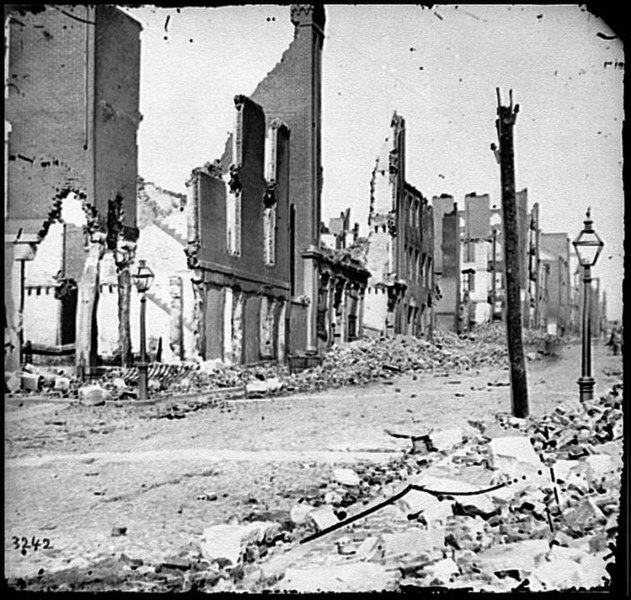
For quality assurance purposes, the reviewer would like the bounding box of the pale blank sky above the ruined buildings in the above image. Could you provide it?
[124,4,624,319]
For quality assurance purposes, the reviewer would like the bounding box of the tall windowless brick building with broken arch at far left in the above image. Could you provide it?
[5,5,141,370]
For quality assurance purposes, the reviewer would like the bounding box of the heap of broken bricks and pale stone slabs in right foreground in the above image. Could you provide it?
[178,384,623,592]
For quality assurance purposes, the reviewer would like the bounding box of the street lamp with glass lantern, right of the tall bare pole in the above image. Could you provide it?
[572,208,605,402]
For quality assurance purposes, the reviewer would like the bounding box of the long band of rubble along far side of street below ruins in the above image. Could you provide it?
[5,324,569,406]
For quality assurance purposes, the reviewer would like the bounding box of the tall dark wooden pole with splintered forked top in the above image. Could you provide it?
[491,88,529,419]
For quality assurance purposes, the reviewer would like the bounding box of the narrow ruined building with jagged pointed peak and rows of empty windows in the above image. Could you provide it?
[364,112,436,336]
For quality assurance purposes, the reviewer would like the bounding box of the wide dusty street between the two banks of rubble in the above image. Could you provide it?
[5,345,622,592]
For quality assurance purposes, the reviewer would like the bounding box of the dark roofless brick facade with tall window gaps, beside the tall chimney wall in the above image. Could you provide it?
[187,96,291,363]
